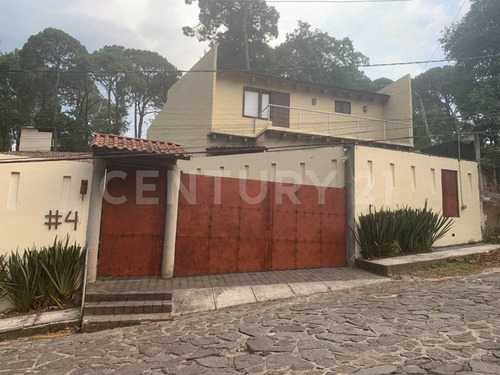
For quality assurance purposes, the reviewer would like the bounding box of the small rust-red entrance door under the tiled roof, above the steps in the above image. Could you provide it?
[97,168,166,277]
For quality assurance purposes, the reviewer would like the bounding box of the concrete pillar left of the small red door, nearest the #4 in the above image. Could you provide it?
[86,159,106,283]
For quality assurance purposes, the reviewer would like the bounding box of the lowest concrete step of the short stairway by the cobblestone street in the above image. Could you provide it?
[82,314,172,332]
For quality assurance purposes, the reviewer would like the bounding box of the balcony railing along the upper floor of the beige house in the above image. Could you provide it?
[254,104,413,145]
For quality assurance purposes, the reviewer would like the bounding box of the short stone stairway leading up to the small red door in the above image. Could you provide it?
[82,281,172,332]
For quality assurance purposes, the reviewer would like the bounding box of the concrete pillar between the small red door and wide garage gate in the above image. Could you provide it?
[161,165,181,279]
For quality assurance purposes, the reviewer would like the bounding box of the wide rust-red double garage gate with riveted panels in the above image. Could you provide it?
[175,174,346,276]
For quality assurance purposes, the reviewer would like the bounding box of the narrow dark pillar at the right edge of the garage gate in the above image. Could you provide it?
[344,145,356,267]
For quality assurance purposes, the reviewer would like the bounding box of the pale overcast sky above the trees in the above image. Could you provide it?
[0,0,469,79]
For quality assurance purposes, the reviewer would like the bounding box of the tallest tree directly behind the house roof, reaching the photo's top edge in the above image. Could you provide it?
[183,0,279,69]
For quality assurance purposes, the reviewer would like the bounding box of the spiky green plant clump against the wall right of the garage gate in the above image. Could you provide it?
[354,202,453,258]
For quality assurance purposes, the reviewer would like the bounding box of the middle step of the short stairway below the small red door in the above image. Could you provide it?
[83,300,172,317]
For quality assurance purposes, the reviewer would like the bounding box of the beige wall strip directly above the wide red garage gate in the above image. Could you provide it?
[178,147,344,187]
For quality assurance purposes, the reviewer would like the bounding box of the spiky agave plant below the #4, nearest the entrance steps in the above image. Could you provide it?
[41,236,85,300]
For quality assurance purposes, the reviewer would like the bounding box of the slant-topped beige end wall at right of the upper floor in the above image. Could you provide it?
[379,74,413,146]
